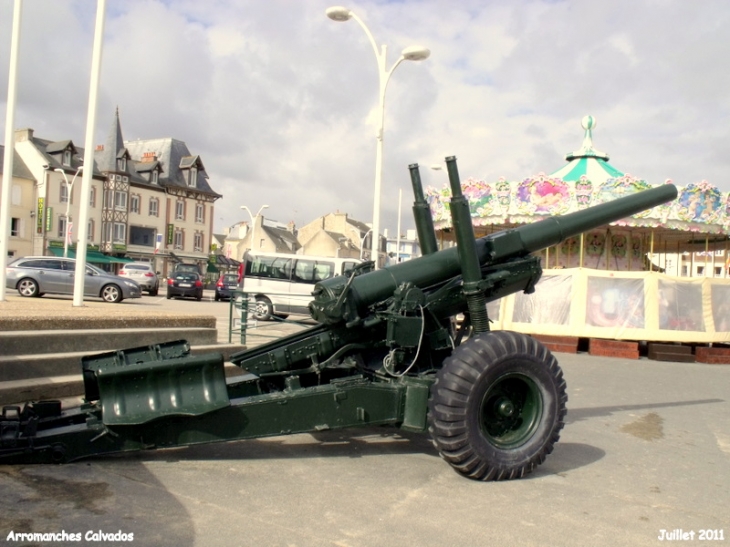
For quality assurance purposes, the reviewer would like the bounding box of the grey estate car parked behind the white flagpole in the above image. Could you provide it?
[5,256,142,302]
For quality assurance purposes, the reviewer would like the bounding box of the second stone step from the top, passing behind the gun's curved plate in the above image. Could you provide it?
[0,338,246,381]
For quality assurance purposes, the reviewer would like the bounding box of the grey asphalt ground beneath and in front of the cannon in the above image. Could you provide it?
[0,352,730,547]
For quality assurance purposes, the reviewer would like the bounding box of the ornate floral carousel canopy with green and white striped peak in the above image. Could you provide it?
[426,116,730,234]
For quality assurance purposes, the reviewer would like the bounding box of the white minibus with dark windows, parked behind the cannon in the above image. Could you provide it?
[243,253,361,321]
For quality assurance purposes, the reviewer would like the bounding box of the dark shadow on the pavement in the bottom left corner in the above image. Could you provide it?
[0,461,195,547]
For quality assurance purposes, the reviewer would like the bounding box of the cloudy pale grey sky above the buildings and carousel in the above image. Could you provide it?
[0,0,730,233]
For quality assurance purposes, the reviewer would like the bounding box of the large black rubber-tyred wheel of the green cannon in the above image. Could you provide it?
[429,331,568,481]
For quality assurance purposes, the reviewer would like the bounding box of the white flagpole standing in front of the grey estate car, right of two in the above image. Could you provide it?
[73,0,106,306]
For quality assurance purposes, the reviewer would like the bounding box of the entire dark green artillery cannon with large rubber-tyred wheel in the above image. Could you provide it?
[0,158,677,480]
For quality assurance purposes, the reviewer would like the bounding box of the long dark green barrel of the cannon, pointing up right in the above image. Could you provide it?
[310,184,677,324]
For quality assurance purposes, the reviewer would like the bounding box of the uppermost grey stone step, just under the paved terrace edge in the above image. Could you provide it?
[0,326,218,358]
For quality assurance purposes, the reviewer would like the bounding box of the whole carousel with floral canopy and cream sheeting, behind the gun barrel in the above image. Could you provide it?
[426,116,730,343]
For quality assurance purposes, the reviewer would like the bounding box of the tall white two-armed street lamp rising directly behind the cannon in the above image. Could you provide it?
[325,6,431,270]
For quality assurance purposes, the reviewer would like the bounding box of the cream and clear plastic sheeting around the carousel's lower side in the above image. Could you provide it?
[488,268,730,343]
